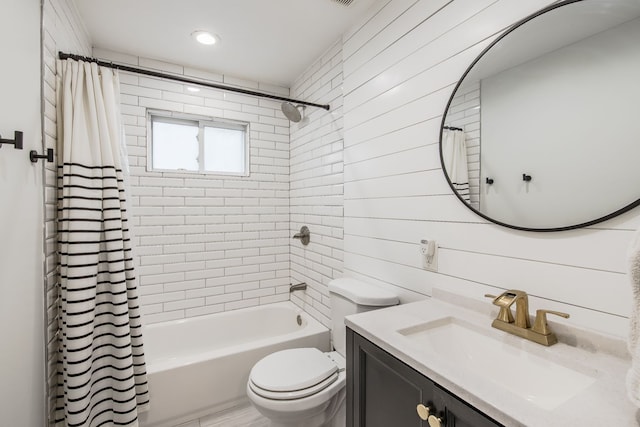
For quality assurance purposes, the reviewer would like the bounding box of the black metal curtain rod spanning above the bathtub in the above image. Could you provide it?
[58,52,330,111]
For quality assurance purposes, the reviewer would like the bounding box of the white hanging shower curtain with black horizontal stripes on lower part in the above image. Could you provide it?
[55,59,149,426]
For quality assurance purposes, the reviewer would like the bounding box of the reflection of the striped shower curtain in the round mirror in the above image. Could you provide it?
[442,129,470,203]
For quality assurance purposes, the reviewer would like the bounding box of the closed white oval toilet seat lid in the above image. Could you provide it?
[250,348,338,392]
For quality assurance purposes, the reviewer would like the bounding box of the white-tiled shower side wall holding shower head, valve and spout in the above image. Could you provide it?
[290,40,344,326]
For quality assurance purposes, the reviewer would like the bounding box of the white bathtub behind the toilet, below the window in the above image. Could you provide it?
[140,301,330,427]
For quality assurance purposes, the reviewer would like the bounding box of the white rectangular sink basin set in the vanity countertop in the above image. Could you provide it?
[398,317,596,410]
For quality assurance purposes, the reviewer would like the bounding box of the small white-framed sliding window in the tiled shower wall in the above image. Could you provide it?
[150,114,248,175]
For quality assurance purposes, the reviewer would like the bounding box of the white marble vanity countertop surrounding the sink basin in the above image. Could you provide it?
[345,293,640,427]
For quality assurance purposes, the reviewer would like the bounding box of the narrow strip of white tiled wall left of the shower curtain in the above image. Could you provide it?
[42,0,91,423]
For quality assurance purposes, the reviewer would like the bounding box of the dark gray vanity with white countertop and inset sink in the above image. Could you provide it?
[345,296,638,427]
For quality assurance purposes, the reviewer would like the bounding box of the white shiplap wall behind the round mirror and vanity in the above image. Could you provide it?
[343,0,640,337]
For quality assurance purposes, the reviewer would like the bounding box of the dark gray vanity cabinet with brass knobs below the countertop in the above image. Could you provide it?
[347,328,501,427]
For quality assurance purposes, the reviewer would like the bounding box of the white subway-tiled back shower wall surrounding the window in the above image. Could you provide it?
[93,49,290,324]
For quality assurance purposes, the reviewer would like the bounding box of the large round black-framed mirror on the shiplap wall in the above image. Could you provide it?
[440,0,640,231]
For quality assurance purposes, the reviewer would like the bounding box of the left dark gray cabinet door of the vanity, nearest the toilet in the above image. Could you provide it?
[347,330,437,427]
